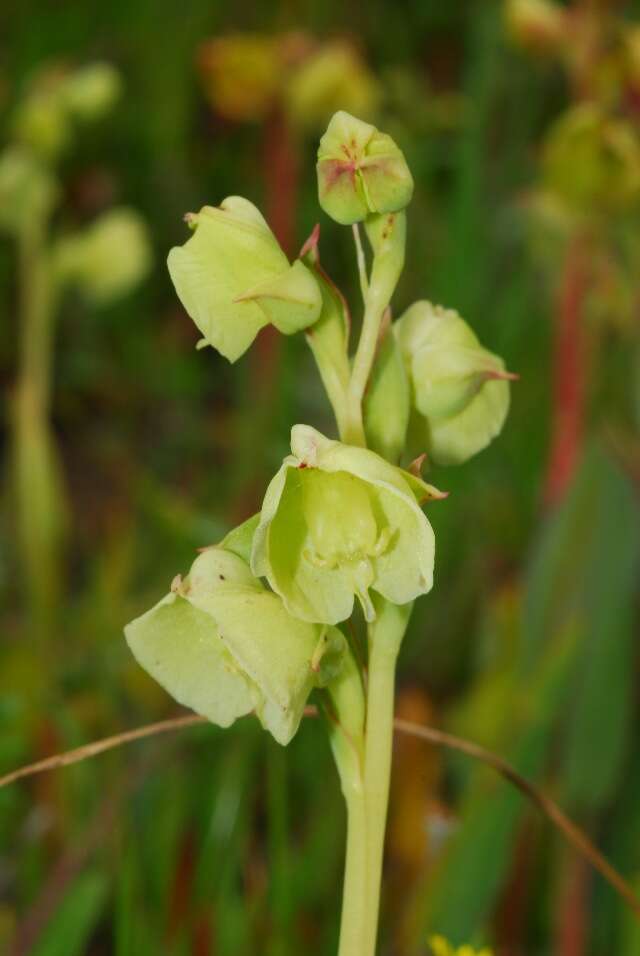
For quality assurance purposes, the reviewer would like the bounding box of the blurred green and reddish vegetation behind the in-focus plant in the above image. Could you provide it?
[0,0,640,956]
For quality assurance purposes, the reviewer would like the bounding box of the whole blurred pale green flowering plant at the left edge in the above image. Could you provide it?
[0,63,150,642]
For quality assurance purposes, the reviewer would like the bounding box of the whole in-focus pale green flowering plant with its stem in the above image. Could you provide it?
[125,112,511,956]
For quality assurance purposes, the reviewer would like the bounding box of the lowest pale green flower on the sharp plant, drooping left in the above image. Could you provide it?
[125,547,345,744]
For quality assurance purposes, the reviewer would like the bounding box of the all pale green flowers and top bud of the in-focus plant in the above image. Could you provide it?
[126,106,509,743]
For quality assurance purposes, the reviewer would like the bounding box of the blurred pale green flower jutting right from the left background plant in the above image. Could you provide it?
[54,208,151,305]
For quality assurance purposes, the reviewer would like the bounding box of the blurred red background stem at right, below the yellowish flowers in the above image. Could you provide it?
[545,239,587,505]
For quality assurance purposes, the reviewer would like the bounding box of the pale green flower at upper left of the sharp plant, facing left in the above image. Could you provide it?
[167,196,322,362]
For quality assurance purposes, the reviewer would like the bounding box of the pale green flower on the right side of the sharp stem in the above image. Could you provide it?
[393,301,514,465]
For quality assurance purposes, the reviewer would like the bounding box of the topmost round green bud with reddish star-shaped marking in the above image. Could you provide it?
[317,110,413,225]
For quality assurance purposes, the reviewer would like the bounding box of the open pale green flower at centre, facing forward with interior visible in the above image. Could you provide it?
[251,425,439,624]
